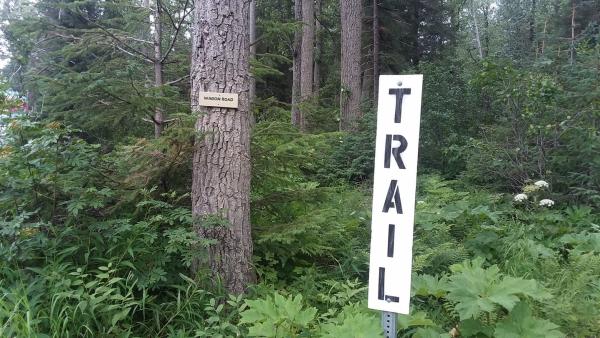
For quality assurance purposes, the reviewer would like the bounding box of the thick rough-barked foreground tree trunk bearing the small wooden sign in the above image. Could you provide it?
[191,0,254,294]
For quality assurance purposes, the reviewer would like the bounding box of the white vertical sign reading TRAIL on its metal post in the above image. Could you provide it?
[369,75,423,337]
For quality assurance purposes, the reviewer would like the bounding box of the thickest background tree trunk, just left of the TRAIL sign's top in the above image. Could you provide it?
[340,0,362,131]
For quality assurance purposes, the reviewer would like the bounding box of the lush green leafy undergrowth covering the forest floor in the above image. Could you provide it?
[0,119,600,337]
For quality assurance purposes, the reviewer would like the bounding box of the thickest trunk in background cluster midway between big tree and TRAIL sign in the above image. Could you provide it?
[300,0,315,131]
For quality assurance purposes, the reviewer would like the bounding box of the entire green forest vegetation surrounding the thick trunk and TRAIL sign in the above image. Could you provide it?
[0,0,600,337]
